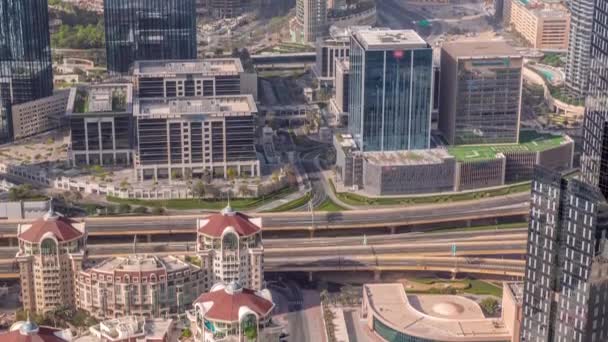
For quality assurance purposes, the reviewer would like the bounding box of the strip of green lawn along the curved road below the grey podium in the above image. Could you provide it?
[330,181,530,205]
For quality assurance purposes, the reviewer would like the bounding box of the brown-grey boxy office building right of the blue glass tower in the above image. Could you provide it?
[439,41,523,145]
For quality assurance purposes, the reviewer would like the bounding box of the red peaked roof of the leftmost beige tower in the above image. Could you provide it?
[18,207,84,243]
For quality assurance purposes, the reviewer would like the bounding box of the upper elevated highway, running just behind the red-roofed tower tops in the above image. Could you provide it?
[0,194,529,238]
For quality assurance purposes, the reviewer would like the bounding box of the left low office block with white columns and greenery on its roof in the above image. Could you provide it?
[66,83,135,166]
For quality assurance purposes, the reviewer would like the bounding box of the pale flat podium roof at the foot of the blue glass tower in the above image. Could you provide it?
[363,148,453,166]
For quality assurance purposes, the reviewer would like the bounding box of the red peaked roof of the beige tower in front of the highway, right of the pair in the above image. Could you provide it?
[198,205,262,237]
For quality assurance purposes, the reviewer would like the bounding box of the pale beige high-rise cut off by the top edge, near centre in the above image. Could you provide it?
[291,0,327,43]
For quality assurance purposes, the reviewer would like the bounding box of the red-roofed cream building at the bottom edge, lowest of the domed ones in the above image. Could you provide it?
[188,282,283,342]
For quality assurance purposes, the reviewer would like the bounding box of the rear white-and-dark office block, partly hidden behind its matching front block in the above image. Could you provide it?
[133,58,247,98]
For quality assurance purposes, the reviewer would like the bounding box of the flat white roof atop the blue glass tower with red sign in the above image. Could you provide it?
[353,28,428,50]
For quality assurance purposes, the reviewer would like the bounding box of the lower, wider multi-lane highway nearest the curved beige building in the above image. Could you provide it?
[0,228,526,278]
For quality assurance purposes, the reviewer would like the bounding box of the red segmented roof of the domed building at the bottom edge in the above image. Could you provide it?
[194,282,274,322]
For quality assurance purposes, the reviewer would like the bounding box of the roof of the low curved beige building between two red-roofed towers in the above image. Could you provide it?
[92,255,194,273]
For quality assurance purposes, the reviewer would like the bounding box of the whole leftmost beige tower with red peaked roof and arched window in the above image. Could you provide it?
[16,208,87,314]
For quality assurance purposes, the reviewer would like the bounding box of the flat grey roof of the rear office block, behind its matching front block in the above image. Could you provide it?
[133,58,243,77]
